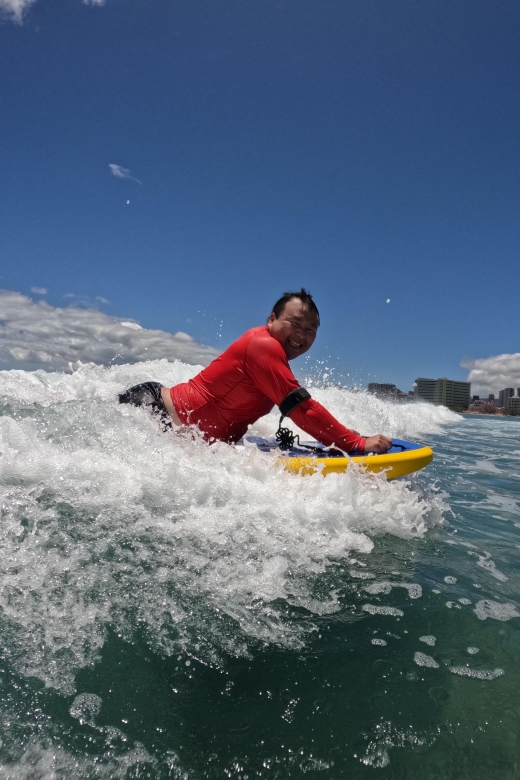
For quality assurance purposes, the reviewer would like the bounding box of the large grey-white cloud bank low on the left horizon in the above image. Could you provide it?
[0,290,218,370]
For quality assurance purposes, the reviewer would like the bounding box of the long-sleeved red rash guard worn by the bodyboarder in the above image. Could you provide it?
[170,325,366,452]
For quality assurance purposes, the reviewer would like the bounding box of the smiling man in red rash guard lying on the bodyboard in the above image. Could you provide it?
[119,287,392,453]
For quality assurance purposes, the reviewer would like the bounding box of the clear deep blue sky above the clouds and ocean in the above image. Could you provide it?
[0,0,520,392]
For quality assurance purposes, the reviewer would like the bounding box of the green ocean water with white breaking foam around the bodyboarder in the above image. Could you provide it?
[0,361,520,780]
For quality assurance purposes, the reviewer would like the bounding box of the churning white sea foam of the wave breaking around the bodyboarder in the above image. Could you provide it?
[0,361,449,693]
